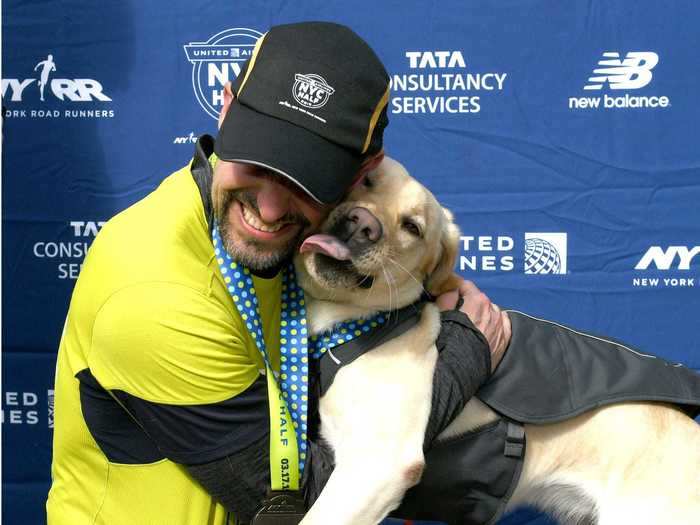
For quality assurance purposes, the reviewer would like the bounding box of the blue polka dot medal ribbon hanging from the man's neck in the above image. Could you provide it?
[212,227,309,477]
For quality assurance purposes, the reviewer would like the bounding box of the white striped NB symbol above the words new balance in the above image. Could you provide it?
[583,51,659,89]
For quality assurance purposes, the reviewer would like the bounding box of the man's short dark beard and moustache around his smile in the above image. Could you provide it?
[213,188,309,275]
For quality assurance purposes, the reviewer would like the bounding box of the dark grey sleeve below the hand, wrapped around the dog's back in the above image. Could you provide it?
[423,310,491,449]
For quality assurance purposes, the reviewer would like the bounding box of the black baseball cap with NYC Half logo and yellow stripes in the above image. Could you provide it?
[215,22,389,204]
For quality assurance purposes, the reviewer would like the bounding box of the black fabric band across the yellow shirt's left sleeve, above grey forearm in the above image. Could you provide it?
[77,369,270,465]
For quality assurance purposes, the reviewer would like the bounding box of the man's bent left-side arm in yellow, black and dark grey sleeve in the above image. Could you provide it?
[84,283,269,519]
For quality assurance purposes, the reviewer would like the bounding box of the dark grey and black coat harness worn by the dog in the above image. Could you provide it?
[312,302,700,525]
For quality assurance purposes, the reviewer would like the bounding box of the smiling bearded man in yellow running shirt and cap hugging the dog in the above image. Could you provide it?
[47,23,510,525]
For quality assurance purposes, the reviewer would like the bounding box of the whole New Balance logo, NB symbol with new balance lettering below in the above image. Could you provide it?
[569,51,671,109]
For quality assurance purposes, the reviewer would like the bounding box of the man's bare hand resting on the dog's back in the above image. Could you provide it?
[435,281,511,372]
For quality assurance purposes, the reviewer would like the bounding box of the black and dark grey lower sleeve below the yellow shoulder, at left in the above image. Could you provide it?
[76,368,270,521]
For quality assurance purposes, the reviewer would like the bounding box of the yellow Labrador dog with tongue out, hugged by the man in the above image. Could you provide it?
[296,158,700,525]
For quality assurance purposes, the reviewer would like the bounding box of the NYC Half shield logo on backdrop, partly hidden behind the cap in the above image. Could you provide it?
[183,27,262,119]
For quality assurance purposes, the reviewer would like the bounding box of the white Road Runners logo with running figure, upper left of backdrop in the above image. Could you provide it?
[2,53,114,118]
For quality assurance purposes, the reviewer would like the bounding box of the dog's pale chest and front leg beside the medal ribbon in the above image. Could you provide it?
[302,304,440,525]
